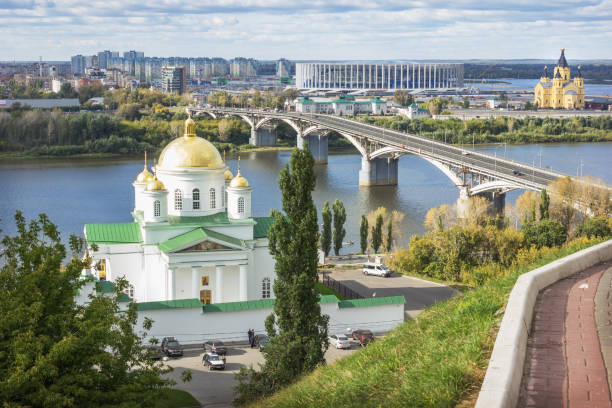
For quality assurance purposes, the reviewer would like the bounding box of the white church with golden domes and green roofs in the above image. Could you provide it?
[85,118,275,304]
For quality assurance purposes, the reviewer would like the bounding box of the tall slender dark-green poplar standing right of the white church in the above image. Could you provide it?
[235,147,329,404]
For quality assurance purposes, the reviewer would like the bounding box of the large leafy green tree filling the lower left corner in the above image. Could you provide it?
[0,212,170,407]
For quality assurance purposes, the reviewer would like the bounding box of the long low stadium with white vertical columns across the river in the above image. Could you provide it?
[295,62,463,91]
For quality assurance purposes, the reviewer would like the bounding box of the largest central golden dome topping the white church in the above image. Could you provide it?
[159,118,223,169]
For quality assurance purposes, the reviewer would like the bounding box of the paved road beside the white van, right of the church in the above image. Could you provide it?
[322,268,459,319]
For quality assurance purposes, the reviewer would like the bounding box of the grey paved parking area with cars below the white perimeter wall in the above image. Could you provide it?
[166,344,361,408]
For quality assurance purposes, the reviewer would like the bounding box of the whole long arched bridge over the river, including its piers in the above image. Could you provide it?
[190,107,566,210]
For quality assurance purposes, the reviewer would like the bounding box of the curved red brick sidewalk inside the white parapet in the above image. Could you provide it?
[518,262,612,408]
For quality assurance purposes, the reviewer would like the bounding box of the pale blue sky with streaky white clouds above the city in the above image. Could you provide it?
[0,0,612,61]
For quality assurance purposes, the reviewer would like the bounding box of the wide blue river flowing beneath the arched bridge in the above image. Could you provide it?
[0,143,612,253]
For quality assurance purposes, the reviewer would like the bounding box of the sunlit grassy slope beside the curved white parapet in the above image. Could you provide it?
[255,239,604,408]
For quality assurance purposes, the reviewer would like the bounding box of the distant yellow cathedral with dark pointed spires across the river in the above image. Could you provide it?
[534,48,584,109]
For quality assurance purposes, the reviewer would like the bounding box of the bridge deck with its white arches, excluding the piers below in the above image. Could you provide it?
[191,107,567,196]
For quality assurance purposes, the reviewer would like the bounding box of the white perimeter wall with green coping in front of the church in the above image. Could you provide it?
[138,303,404,344]
